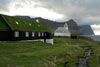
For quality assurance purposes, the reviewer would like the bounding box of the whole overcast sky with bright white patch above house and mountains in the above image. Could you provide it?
[0,0,100,24]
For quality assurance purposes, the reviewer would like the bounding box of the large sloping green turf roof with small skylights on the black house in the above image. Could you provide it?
[2,15,51,32]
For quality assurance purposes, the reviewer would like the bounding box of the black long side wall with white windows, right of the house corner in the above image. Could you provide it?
[12,31,52,41]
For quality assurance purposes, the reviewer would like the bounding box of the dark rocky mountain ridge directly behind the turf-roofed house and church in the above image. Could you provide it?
[18,16,80,34]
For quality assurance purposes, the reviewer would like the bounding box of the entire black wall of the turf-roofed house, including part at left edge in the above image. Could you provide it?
[0,31,53,43]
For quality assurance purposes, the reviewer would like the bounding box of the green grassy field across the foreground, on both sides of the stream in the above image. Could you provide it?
[0,38,100,67]
